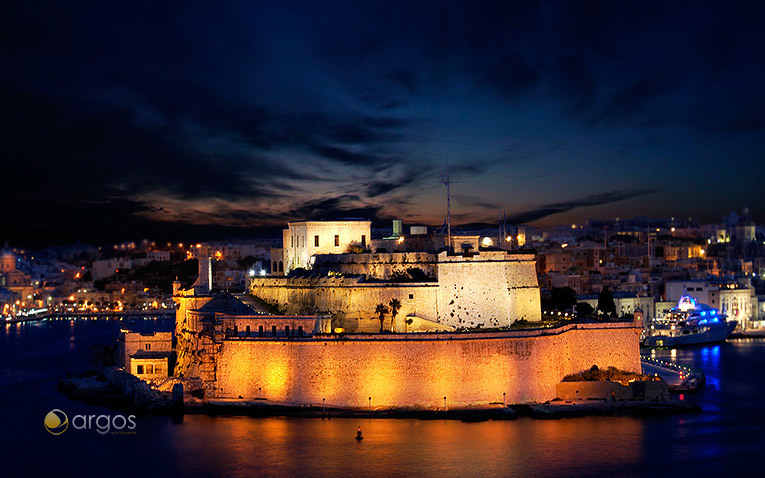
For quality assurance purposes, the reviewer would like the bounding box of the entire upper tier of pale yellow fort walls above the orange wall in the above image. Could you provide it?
[250,251,541,332]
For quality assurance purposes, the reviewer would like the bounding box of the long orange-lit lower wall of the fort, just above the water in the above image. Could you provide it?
[215,324,641,409]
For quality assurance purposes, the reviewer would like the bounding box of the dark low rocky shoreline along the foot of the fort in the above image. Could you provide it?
[58,369,701,422]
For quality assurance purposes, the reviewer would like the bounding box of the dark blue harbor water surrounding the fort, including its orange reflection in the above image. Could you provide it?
[0,318,765,477]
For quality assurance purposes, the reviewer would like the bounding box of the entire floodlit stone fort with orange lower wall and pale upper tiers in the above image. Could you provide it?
[169,222,641,410]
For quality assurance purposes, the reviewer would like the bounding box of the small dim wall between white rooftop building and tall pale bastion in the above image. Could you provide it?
[313,252,436,280]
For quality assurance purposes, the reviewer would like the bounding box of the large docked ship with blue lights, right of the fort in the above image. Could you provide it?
[644,294,738,347]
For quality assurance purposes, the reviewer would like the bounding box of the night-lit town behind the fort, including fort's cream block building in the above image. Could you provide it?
[0,208,765,331]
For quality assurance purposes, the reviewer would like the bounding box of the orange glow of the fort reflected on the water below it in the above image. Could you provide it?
[161,416,645,477]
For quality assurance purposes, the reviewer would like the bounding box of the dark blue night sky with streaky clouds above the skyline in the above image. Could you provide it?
[0,1,765,243]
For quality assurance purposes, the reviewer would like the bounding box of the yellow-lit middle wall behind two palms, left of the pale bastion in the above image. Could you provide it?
[250,277,438,332]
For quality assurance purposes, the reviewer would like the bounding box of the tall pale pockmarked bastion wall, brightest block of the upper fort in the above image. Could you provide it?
[438,251,542,327]
